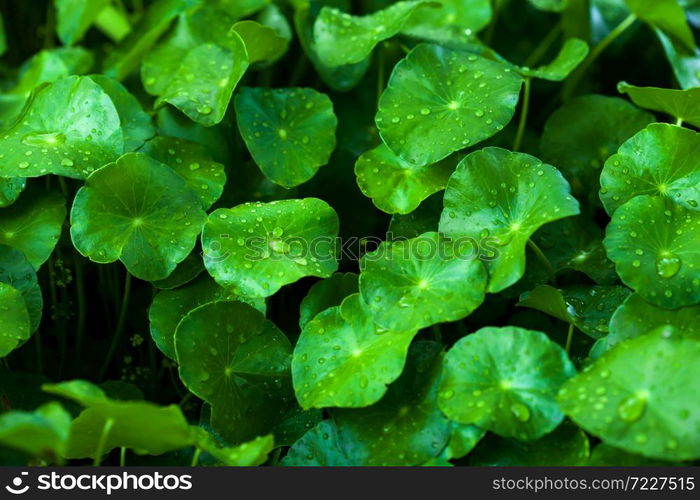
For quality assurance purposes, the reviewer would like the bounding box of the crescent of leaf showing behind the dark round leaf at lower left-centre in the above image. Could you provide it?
[148,275,265,360]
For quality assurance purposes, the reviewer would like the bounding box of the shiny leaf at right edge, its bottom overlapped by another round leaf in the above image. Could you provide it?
[600,123,700,214]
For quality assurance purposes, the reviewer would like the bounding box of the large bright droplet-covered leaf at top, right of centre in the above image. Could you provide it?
[376,44,523,165]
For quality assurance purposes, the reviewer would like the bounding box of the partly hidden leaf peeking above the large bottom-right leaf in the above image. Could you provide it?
[605,293,700,349]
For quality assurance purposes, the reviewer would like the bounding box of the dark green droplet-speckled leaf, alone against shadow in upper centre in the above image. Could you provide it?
[235,87,338,188]
